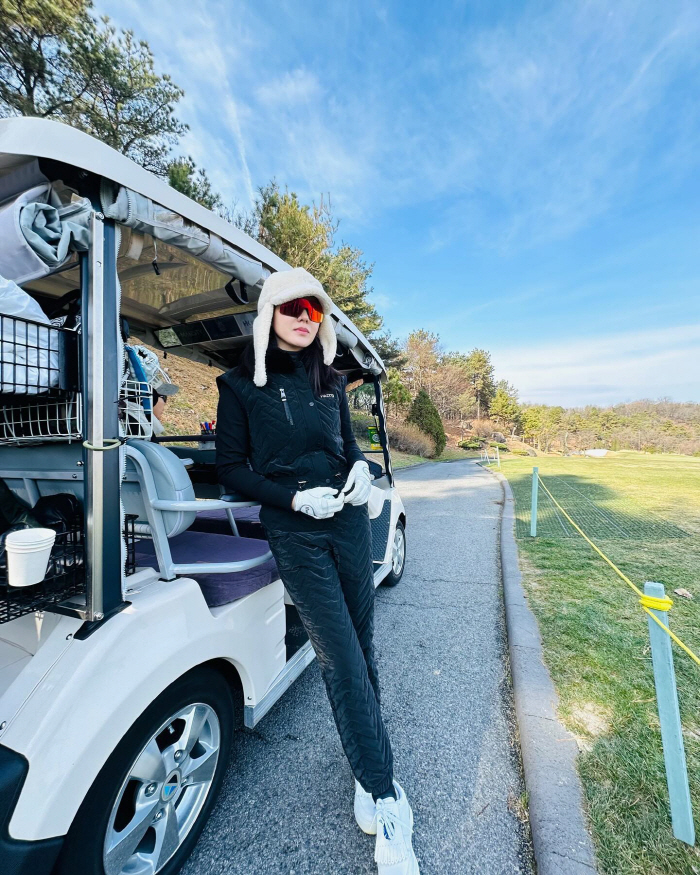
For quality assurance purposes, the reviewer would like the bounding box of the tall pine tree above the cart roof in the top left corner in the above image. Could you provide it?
[0,0,187,176]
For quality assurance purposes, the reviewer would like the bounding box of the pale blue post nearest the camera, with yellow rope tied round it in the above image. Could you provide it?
[644,582,695,846]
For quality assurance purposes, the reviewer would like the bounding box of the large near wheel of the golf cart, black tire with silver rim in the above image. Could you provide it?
[55,666,234,875]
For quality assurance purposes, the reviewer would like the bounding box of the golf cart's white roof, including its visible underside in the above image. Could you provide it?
[0,118,385,378]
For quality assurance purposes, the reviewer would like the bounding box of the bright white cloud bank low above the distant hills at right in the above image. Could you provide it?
[492,323,700,406]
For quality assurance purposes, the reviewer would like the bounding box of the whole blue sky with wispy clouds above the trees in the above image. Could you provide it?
[97,0,700,405]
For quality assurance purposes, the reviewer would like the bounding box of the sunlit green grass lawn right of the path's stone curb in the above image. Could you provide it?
[501,453,700,875]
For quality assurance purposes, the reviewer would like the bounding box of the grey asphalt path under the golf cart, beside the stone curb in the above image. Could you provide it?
[183,461,532,875]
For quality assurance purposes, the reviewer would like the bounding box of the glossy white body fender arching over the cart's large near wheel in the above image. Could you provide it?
[0,578,286,841]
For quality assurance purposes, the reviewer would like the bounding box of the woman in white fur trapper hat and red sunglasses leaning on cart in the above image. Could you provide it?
[216,268,418,875]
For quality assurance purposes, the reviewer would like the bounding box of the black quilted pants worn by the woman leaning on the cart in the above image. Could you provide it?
[267,504,393,796]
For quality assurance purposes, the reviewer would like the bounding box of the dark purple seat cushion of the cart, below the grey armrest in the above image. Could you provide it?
[136,530,279,608]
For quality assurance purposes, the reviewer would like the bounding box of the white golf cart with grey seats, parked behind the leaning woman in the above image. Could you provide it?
[0,118,405,875]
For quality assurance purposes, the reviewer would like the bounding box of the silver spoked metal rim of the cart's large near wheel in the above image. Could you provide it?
[103,703,221,875]
